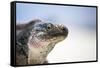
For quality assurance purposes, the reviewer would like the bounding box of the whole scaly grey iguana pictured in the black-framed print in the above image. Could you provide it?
[16,20,68,65]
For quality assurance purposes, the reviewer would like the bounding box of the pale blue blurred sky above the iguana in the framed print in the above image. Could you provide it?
[16,3,96,28]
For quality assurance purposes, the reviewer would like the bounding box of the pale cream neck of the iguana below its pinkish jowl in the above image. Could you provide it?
[28,36,54,64]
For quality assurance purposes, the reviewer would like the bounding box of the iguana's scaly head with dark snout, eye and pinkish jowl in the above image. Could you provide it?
[29,22,68,49]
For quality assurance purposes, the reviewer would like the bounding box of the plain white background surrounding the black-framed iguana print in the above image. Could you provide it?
[0,0,100,68]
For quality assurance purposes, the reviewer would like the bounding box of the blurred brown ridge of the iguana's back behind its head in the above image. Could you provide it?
[16,19,41,30]
